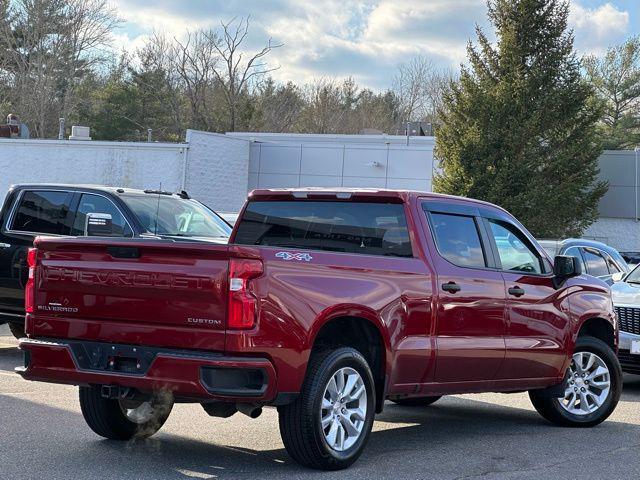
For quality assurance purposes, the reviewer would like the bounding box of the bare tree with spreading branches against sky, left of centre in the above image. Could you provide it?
[214,17,282,132]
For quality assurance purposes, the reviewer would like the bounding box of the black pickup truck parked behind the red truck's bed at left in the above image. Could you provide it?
[0,184,231,338]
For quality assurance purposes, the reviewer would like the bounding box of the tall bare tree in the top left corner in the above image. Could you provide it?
[0,0,119,137]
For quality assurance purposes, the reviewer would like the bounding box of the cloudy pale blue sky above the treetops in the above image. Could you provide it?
[112,0,640,90]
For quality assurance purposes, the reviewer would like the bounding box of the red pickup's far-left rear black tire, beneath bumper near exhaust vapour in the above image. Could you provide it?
[80,386,173,440]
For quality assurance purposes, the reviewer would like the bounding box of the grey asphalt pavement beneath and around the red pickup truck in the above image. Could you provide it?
[0,395,640,479]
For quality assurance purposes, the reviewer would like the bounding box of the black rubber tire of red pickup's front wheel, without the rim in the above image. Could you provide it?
[529,336,622,427]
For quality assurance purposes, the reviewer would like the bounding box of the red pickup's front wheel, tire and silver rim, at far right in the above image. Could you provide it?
[529,336,622,427]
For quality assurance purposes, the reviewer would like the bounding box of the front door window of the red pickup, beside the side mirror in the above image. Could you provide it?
[488,220,542,274]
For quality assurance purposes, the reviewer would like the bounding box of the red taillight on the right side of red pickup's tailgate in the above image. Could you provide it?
[227,258,263,328]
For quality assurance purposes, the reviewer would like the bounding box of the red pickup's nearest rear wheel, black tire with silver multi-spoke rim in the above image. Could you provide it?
[278,347,375,470]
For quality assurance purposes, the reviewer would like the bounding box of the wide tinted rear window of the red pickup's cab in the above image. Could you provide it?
[235,201,413,257]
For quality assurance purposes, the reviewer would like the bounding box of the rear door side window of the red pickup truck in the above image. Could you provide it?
[430,213,487,267]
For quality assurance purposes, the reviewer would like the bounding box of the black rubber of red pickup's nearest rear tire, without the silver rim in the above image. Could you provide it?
[278,347,375,470]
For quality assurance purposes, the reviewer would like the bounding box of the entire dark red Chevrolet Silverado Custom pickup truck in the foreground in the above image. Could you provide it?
[17,189,621,469]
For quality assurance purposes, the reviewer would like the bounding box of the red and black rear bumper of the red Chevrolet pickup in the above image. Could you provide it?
[16,338,277,404]
